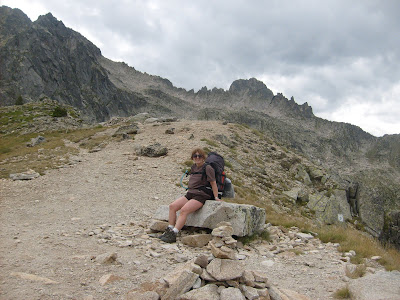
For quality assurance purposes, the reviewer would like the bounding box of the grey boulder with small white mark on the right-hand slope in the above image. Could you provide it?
[307,190,351,224]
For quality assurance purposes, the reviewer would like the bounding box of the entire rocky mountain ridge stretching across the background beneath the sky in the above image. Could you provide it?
[0,6,400,245]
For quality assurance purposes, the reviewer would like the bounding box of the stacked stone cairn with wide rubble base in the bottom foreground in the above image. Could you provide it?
[127,222,296,300]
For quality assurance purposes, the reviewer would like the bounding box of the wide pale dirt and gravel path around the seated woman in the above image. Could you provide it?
[0,122,374,299]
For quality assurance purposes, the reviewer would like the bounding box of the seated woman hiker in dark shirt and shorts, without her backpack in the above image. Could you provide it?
[160,148,222,243]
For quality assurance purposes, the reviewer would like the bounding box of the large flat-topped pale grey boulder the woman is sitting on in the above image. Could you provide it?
[154,200,266,236]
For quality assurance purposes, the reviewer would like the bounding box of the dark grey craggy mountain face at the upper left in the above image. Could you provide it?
[0,6,189,121]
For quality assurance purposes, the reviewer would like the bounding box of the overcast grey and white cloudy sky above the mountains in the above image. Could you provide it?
[0,0,400,136]
